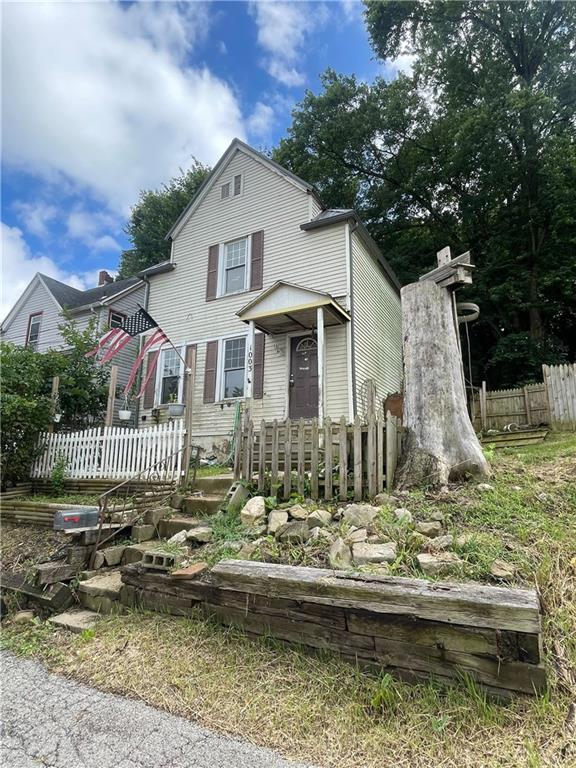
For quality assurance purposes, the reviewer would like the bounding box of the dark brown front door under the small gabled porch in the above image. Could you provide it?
[288,336,318,419]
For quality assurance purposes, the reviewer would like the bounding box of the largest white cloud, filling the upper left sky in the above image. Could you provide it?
[2,2,244,215]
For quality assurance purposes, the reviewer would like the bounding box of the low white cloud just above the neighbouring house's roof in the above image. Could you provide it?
[0,222,112,320]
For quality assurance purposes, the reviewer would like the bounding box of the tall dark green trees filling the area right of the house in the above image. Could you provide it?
[274,0,576,386]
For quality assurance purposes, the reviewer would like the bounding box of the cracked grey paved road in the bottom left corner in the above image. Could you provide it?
[0,652,316,768]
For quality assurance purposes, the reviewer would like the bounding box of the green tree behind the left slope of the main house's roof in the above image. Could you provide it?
[118,160,210,278]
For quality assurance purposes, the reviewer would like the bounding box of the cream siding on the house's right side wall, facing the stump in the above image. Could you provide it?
[352,233,402,416]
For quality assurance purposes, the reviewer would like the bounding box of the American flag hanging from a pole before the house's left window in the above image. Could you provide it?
[86,308,169,397]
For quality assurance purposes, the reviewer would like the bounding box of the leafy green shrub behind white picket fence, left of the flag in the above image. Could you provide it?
[45,316,110,430]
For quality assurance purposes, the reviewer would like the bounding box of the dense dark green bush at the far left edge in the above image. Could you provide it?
[0,342,53,488]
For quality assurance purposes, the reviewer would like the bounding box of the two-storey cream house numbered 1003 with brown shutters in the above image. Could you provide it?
[140,139,402,453]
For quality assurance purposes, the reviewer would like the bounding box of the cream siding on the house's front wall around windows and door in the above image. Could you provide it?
[142,152,348,448]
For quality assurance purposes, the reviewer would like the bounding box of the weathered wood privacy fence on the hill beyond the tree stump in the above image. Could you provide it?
[473,363,576,430]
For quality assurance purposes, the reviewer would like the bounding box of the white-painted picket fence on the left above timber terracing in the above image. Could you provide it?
[31,420,185,480]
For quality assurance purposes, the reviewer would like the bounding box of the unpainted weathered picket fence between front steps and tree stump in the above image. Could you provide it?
[234,413,401,501]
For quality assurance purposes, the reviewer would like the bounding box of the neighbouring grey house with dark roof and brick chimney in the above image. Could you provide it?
[0,270,146,424]
